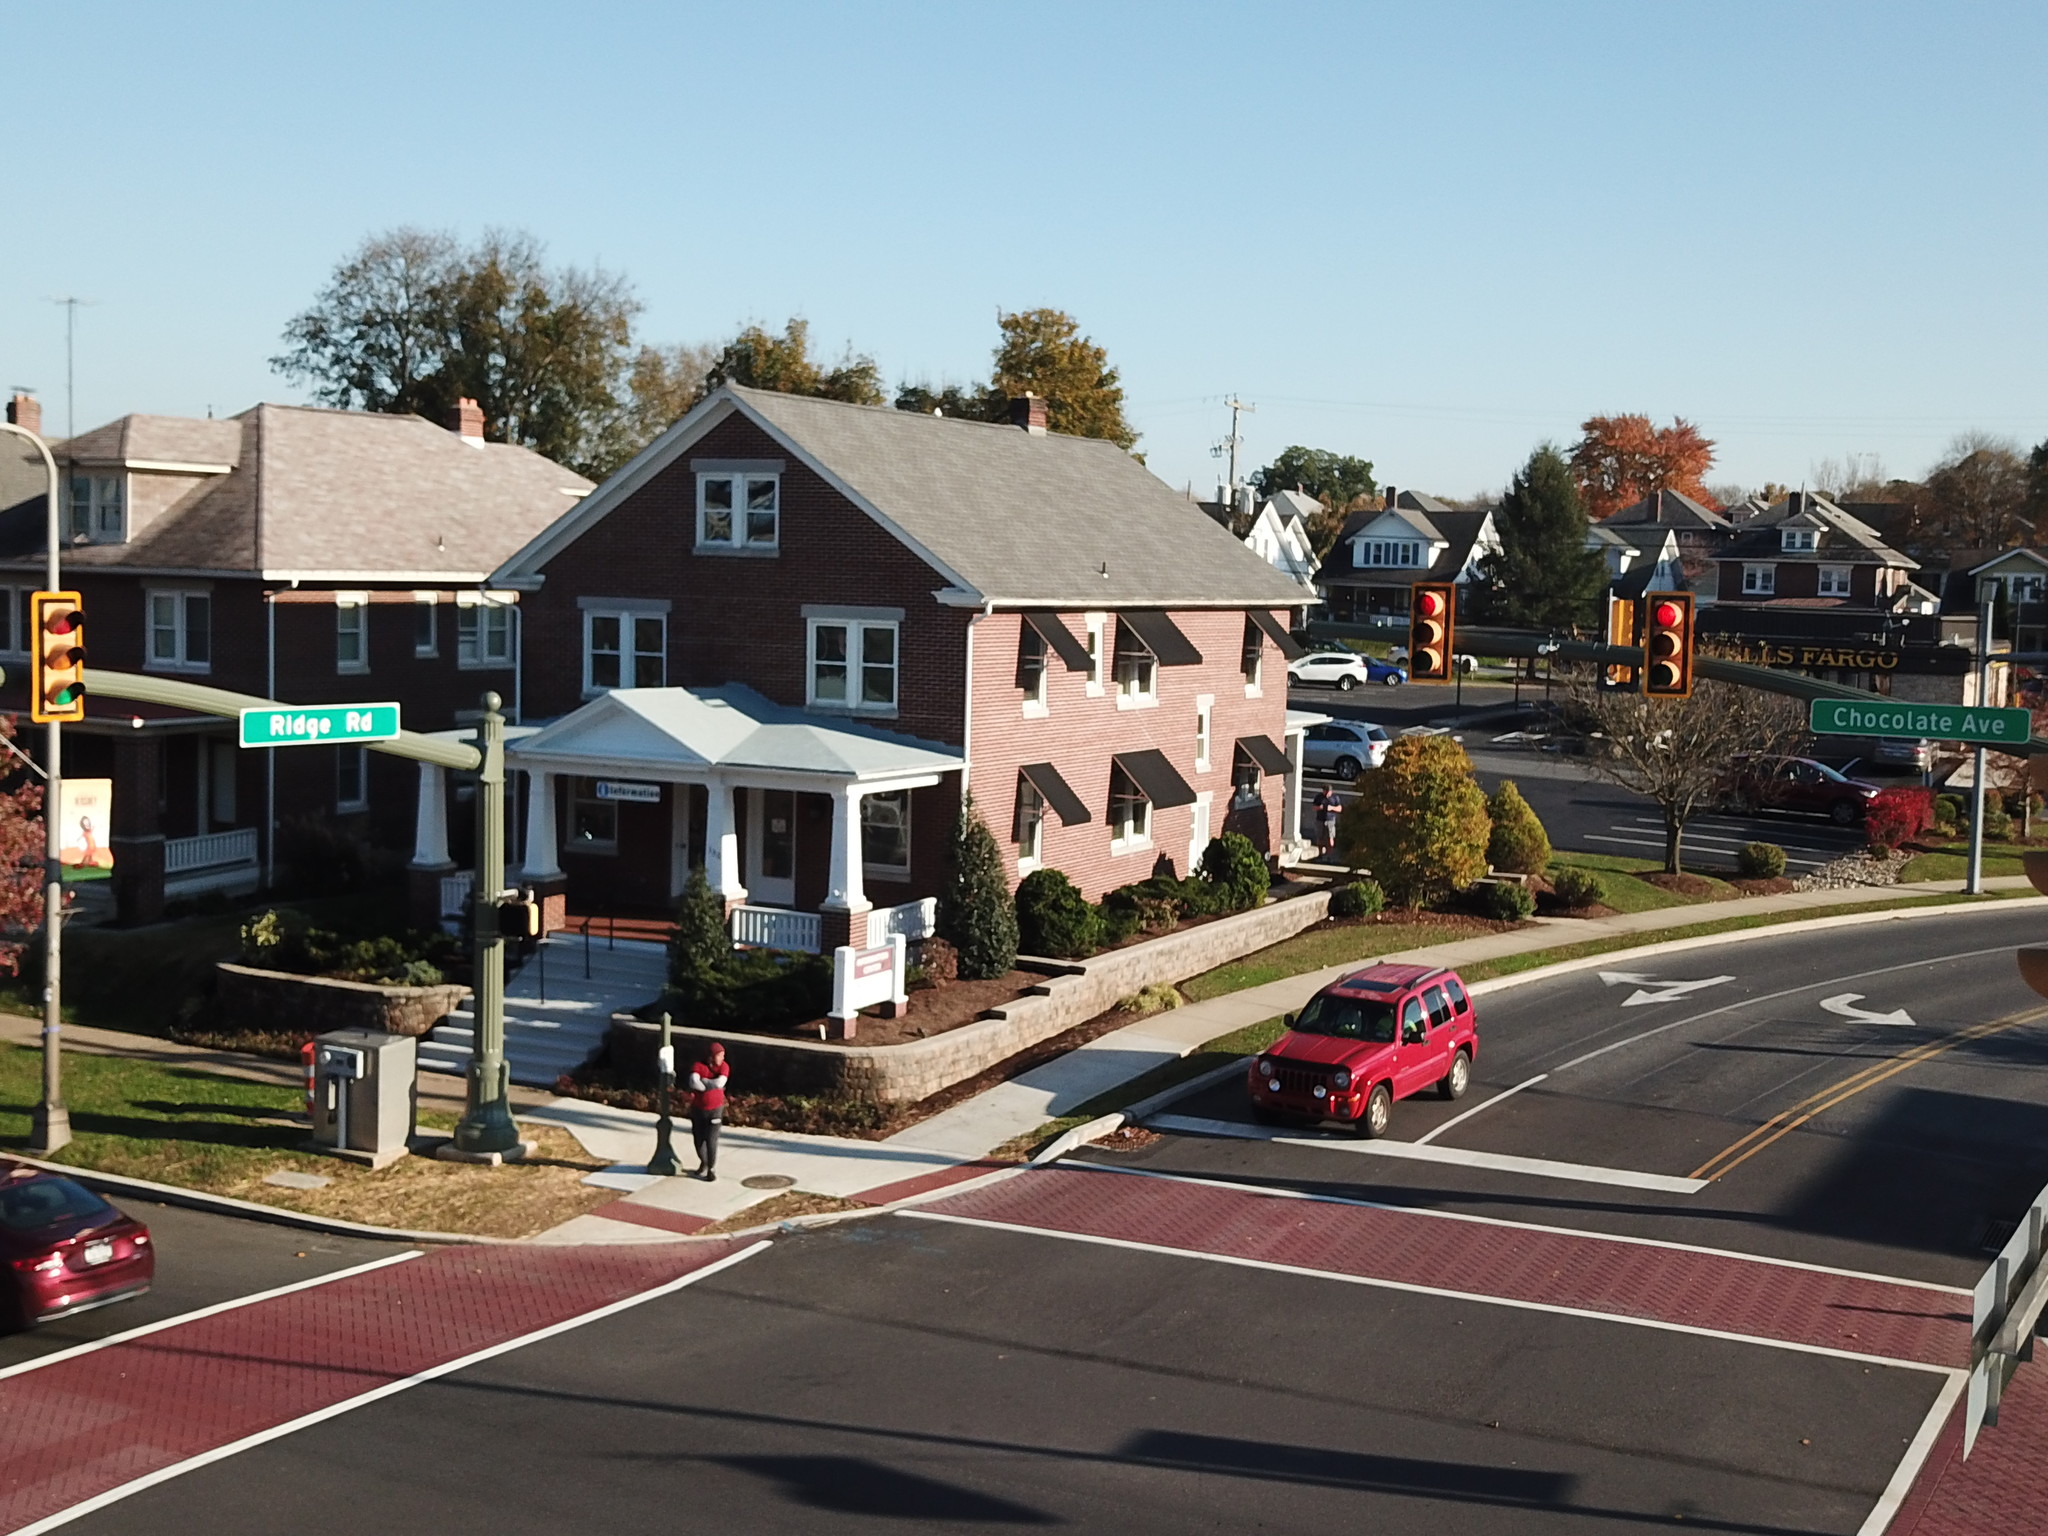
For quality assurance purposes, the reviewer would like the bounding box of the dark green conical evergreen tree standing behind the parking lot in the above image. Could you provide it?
[1479,442,1608,629]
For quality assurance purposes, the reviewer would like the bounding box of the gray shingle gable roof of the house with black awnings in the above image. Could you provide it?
[498,385,1313,608]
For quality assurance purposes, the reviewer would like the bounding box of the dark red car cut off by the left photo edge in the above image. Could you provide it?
[0,1161,156,1327]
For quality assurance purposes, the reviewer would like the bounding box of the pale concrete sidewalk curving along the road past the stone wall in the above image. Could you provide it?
[885,874,2028,1157]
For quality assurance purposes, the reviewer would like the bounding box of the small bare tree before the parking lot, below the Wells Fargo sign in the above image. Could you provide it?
[1571,674,1806,874]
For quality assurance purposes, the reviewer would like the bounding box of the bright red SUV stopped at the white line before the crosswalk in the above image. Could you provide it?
[1245,965,1479,1137]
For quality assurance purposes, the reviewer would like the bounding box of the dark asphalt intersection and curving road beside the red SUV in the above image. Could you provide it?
[51,905,2048,1536]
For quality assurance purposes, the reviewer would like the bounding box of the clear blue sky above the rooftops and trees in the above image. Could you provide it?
[0,0,2048,496]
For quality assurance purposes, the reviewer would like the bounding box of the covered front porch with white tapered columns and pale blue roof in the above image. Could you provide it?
[414,684,965,952]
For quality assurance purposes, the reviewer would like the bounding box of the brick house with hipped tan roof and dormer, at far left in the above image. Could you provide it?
[0,397,590,922]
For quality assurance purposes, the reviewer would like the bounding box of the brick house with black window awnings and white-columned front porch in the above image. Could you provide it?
[468,385,1313,950]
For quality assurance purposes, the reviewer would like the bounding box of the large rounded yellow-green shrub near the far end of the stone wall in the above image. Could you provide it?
[1337,735,1493,907]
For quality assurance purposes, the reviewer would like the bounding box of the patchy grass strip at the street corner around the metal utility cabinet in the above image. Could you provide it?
[0,1044,618,1237]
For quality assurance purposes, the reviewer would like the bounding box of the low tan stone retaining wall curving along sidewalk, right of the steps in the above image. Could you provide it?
[608,891,1329,1104]
